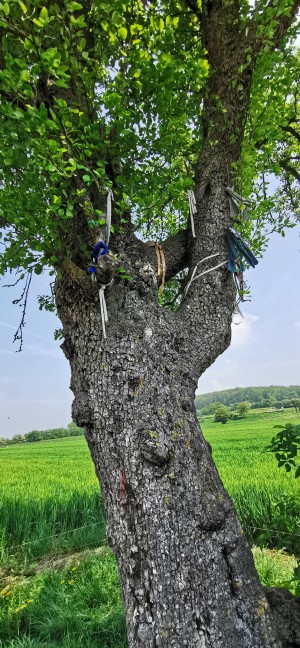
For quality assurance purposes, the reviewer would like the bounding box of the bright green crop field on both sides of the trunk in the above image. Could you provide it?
[0,410,300,561]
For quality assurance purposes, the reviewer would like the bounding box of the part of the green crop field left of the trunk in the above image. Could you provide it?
[0,437,105,560]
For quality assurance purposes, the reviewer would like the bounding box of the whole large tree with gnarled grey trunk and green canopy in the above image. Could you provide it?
[0,0,299,648]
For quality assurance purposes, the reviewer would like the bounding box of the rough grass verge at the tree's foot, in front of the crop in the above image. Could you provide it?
[0,547,296,648]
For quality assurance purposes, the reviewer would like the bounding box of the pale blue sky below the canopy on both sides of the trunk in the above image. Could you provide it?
[0,228,300,437]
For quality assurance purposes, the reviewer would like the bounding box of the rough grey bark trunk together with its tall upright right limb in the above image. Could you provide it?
[52,2,299,648]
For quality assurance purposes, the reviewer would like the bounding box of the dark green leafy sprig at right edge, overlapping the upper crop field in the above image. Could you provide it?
[265,423,300,477]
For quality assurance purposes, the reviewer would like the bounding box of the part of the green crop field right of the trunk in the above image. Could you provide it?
[201,410,300,555]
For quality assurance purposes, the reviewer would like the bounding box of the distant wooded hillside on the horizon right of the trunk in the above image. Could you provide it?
[195,385,300,413]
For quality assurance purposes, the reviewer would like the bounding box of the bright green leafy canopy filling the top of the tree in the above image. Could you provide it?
[0,0,299,284]
